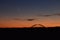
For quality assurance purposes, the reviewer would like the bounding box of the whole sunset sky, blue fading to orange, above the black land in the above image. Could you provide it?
[0,0,60,27]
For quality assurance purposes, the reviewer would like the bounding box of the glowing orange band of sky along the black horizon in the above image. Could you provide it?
[0,20,60,28]
